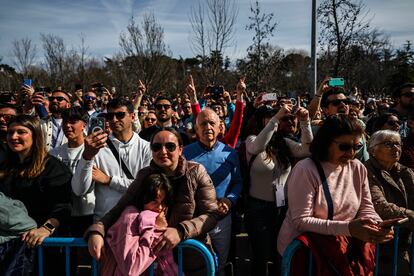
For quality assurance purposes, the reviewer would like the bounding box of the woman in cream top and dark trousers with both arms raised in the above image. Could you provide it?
[245,104,313,275]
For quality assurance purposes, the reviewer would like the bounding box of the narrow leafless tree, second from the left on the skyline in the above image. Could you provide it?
[40,34,67,86]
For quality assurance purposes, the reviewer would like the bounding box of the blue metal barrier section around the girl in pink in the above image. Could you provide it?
[37,238,215,276]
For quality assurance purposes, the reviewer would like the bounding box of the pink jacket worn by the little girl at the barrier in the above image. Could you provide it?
[101,206,178,276]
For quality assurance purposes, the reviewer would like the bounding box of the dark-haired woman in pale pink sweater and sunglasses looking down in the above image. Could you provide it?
[278,114,393,275]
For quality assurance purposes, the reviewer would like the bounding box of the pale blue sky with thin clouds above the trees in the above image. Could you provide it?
[0,0,414,68]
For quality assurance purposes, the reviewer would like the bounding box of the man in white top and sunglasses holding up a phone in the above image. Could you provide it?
[72,98,152,220]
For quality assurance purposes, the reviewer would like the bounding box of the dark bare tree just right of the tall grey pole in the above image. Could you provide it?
[318,0,371,75]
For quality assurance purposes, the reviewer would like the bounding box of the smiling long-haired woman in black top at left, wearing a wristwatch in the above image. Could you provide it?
[0,115,72,275]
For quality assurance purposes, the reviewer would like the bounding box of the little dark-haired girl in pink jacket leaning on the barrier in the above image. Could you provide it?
[101,173,178,276]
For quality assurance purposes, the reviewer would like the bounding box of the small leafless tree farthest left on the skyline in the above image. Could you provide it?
[13,37,36,76]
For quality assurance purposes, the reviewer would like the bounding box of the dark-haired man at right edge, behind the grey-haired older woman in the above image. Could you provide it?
[389,83,414,138]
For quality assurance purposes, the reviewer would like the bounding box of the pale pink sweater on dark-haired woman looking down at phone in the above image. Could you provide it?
[277,158,381,254]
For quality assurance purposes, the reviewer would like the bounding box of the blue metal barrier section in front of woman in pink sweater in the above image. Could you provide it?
[281,226,414,276]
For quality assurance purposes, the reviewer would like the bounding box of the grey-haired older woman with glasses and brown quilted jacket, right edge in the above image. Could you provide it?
[365,130,414,275]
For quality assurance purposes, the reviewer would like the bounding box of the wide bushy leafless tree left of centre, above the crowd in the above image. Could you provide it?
[120,13,171,93]
